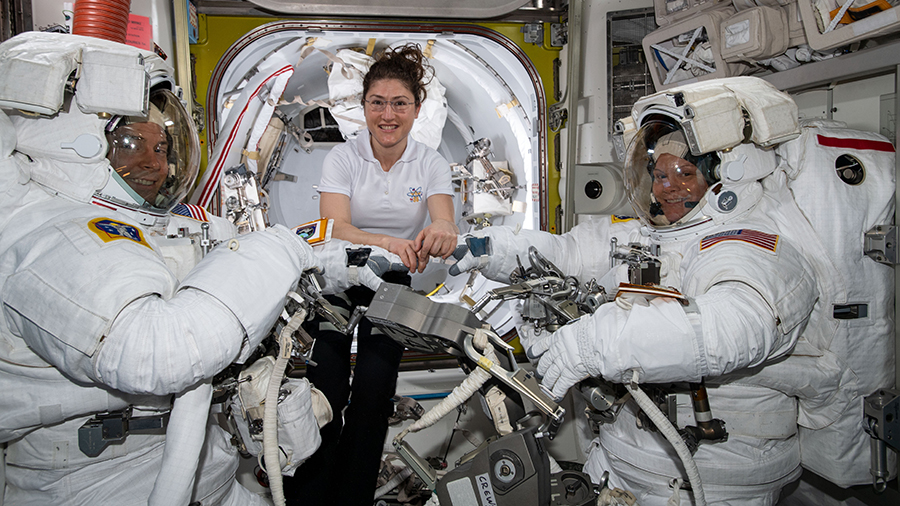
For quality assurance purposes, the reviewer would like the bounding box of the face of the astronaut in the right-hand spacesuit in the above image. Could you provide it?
[653,153,708,223]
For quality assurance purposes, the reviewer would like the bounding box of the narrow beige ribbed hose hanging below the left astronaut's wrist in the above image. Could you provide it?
[263,308,306,506]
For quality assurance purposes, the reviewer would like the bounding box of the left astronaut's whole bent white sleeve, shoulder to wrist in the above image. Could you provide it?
[0,220,315,395]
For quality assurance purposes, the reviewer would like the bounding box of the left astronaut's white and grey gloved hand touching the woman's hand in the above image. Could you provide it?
[313,239,408,295]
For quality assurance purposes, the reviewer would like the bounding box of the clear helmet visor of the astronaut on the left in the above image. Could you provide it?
[106,90,200,211]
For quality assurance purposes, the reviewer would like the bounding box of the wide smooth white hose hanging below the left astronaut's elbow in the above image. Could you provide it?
[147,378,212,506]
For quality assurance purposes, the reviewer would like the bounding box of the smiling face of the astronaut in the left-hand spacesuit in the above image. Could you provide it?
[107,122,169,205]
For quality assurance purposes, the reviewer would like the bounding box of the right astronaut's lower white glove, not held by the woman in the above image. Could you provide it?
[529,317,599,399]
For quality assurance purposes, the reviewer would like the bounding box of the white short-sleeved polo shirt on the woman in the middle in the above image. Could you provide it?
[318,129,453,239]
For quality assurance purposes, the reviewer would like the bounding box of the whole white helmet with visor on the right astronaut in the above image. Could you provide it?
[615,77,800,239]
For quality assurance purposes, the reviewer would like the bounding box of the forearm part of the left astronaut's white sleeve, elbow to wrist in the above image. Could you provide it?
[95,226,317,394]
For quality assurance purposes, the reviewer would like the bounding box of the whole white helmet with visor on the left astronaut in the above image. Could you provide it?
[0,32,200,225]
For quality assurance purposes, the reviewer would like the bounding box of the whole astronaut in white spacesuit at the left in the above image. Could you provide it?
[0,32,394,506]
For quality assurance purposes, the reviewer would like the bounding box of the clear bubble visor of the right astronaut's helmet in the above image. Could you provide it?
[625,120,719,228]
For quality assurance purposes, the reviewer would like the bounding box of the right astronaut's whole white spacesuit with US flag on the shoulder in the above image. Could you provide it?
[454,78,858,505]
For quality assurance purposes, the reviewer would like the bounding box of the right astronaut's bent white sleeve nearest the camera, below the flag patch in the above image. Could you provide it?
[576,233,818,383]
